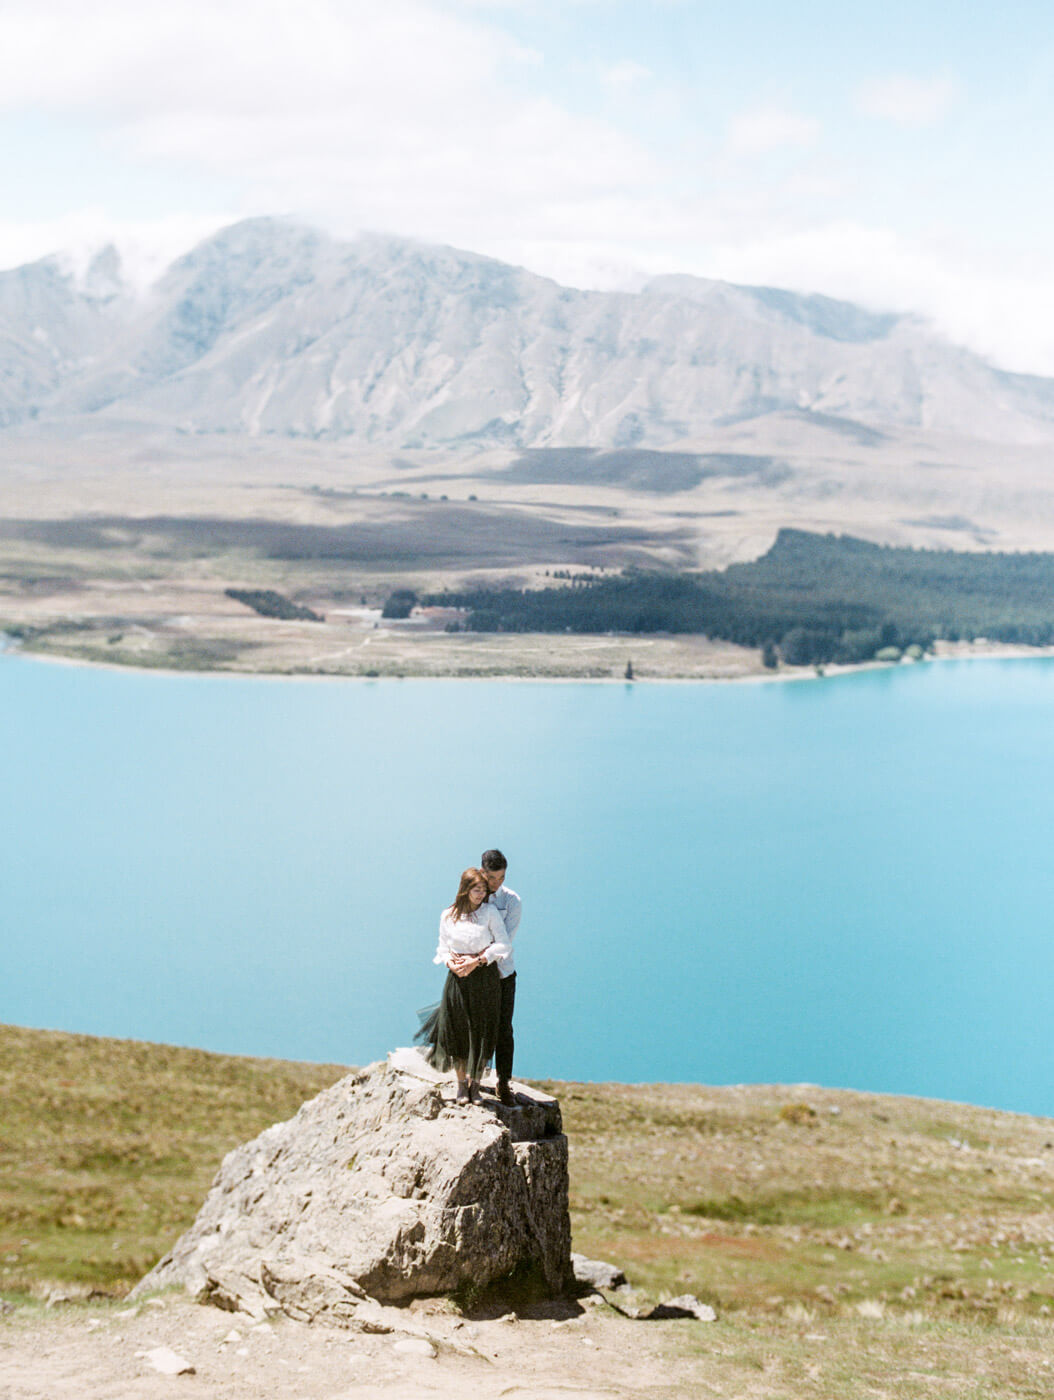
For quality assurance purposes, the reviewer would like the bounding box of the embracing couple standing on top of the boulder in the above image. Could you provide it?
[416,851,521,1107]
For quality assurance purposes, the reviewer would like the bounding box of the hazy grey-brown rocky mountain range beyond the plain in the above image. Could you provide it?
[0,218,1054,449]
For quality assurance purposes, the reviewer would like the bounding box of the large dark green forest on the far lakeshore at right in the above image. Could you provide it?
[426,529,1054,665]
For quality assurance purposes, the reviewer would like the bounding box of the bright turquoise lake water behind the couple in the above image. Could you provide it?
[0,654,1054,1114]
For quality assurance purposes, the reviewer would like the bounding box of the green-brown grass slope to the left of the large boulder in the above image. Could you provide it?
[0,1026,343,1298]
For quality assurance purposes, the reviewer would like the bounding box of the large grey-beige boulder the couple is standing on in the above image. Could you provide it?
[136,1050,571,1326]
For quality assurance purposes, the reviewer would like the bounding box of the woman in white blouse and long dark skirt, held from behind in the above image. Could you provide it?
[417,865,510,1103]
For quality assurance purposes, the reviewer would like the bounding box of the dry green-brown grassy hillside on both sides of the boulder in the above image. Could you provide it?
[0,1026,1054,1400]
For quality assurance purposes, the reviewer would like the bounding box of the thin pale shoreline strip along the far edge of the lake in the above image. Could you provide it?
[8,633,1054,687]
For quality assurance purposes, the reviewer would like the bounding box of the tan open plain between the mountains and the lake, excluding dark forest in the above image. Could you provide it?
[0,414,1054,679]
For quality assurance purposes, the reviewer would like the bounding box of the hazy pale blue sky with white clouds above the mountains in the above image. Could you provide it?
[0,0,1054,374]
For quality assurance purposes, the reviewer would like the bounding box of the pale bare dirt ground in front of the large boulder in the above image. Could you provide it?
[0,1296,712,1400]
